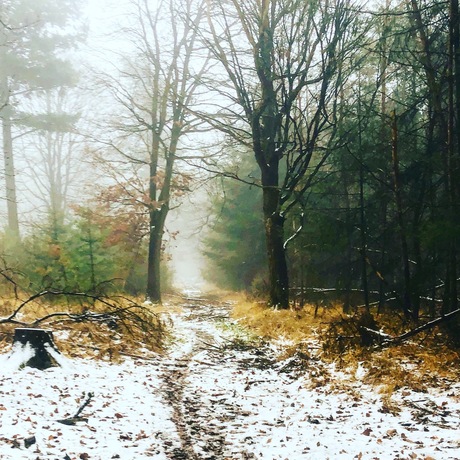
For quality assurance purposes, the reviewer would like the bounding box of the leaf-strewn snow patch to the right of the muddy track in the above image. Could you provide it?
[188,348,460,460]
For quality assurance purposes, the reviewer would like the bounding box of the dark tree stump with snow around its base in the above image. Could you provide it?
[13,328,59,370]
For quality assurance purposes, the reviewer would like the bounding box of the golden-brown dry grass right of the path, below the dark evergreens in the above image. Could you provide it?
[233,300,460,395]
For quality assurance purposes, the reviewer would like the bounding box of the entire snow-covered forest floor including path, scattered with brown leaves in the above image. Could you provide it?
[0,293,460,460]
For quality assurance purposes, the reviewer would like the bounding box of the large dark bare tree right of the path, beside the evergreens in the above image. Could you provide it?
[203,0,360,308]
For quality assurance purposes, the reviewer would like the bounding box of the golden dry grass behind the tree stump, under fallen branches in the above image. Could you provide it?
[0,294,167,361]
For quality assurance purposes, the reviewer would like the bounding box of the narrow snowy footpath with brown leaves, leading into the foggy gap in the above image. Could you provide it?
[161,295,253,460]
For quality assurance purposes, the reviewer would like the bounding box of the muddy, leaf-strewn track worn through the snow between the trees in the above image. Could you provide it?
[162,298,241,460]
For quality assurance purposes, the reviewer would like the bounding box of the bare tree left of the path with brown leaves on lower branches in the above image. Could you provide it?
[97,0,207,302]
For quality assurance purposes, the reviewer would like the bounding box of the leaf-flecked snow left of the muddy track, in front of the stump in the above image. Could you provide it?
[0,350,177,460]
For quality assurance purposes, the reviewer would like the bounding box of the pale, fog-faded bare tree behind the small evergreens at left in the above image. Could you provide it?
[18,87,86,237]
